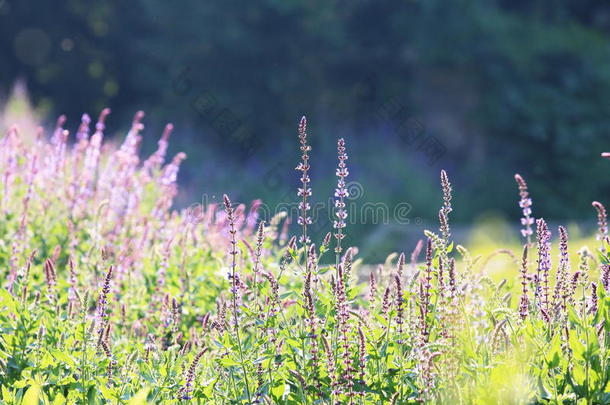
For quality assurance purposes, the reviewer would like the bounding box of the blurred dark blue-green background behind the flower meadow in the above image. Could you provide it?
[0,0,610,256]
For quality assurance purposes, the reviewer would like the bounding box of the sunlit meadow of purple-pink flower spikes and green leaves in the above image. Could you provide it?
[0,109,610,405]
